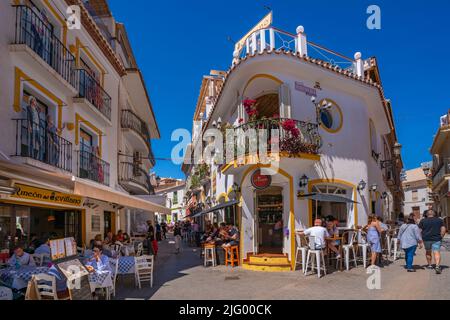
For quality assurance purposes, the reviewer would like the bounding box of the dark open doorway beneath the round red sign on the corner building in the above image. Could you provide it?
[255,187,284,254]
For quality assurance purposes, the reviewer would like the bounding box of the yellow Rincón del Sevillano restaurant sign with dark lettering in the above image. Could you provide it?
[11,183,82,207]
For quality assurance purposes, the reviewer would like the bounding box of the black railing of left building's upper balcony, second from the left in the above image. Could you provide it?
[77,69,111,120]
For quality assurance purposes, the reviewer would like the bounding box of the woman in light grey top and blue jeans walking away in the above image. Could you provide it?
[398,213,423,272]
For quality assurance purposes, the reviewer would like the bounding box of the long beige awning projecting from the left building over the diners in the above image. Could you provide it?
[74,181,171,214]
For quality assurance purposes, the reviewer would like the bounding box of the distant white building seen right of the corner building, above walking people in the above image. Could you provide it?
[402,168,433,218]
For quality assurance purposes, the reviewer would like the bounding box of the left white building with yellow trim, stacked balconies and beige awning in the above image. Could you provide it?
[0,0,165,249]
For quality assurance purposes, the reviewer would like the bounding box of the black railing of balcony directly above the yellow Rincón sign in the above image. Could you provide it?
[14,119,72,172]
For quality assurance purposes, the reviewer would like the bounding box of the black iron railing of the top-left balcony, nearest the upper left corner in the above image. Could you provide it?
[14,5,76,88]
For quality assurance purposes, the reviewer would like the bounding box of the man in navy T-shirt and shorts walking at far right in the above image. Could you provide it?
[419,210,447,274]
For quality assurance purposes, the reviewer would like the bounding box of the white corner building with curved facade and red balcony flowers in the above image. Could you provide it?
[183,15,403,270]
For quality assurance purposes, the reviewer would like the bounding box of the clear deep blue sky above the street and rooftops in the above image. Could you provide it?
[109,0,450,178]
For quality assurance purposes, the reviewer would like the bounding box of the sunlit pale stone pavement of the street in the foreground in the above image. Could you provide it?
[117,235,450,300]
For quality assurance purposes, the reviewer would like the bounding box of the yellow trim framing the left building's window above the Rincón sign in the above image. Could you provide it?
[13,67,64,130]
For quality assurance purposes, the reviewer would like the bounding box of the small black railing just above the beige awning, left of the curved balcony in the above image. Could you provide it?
[78,151,110,186]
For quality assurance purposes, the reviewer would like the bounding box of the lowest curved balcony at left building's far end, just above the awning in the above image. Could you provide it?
[119,162,154,195]
